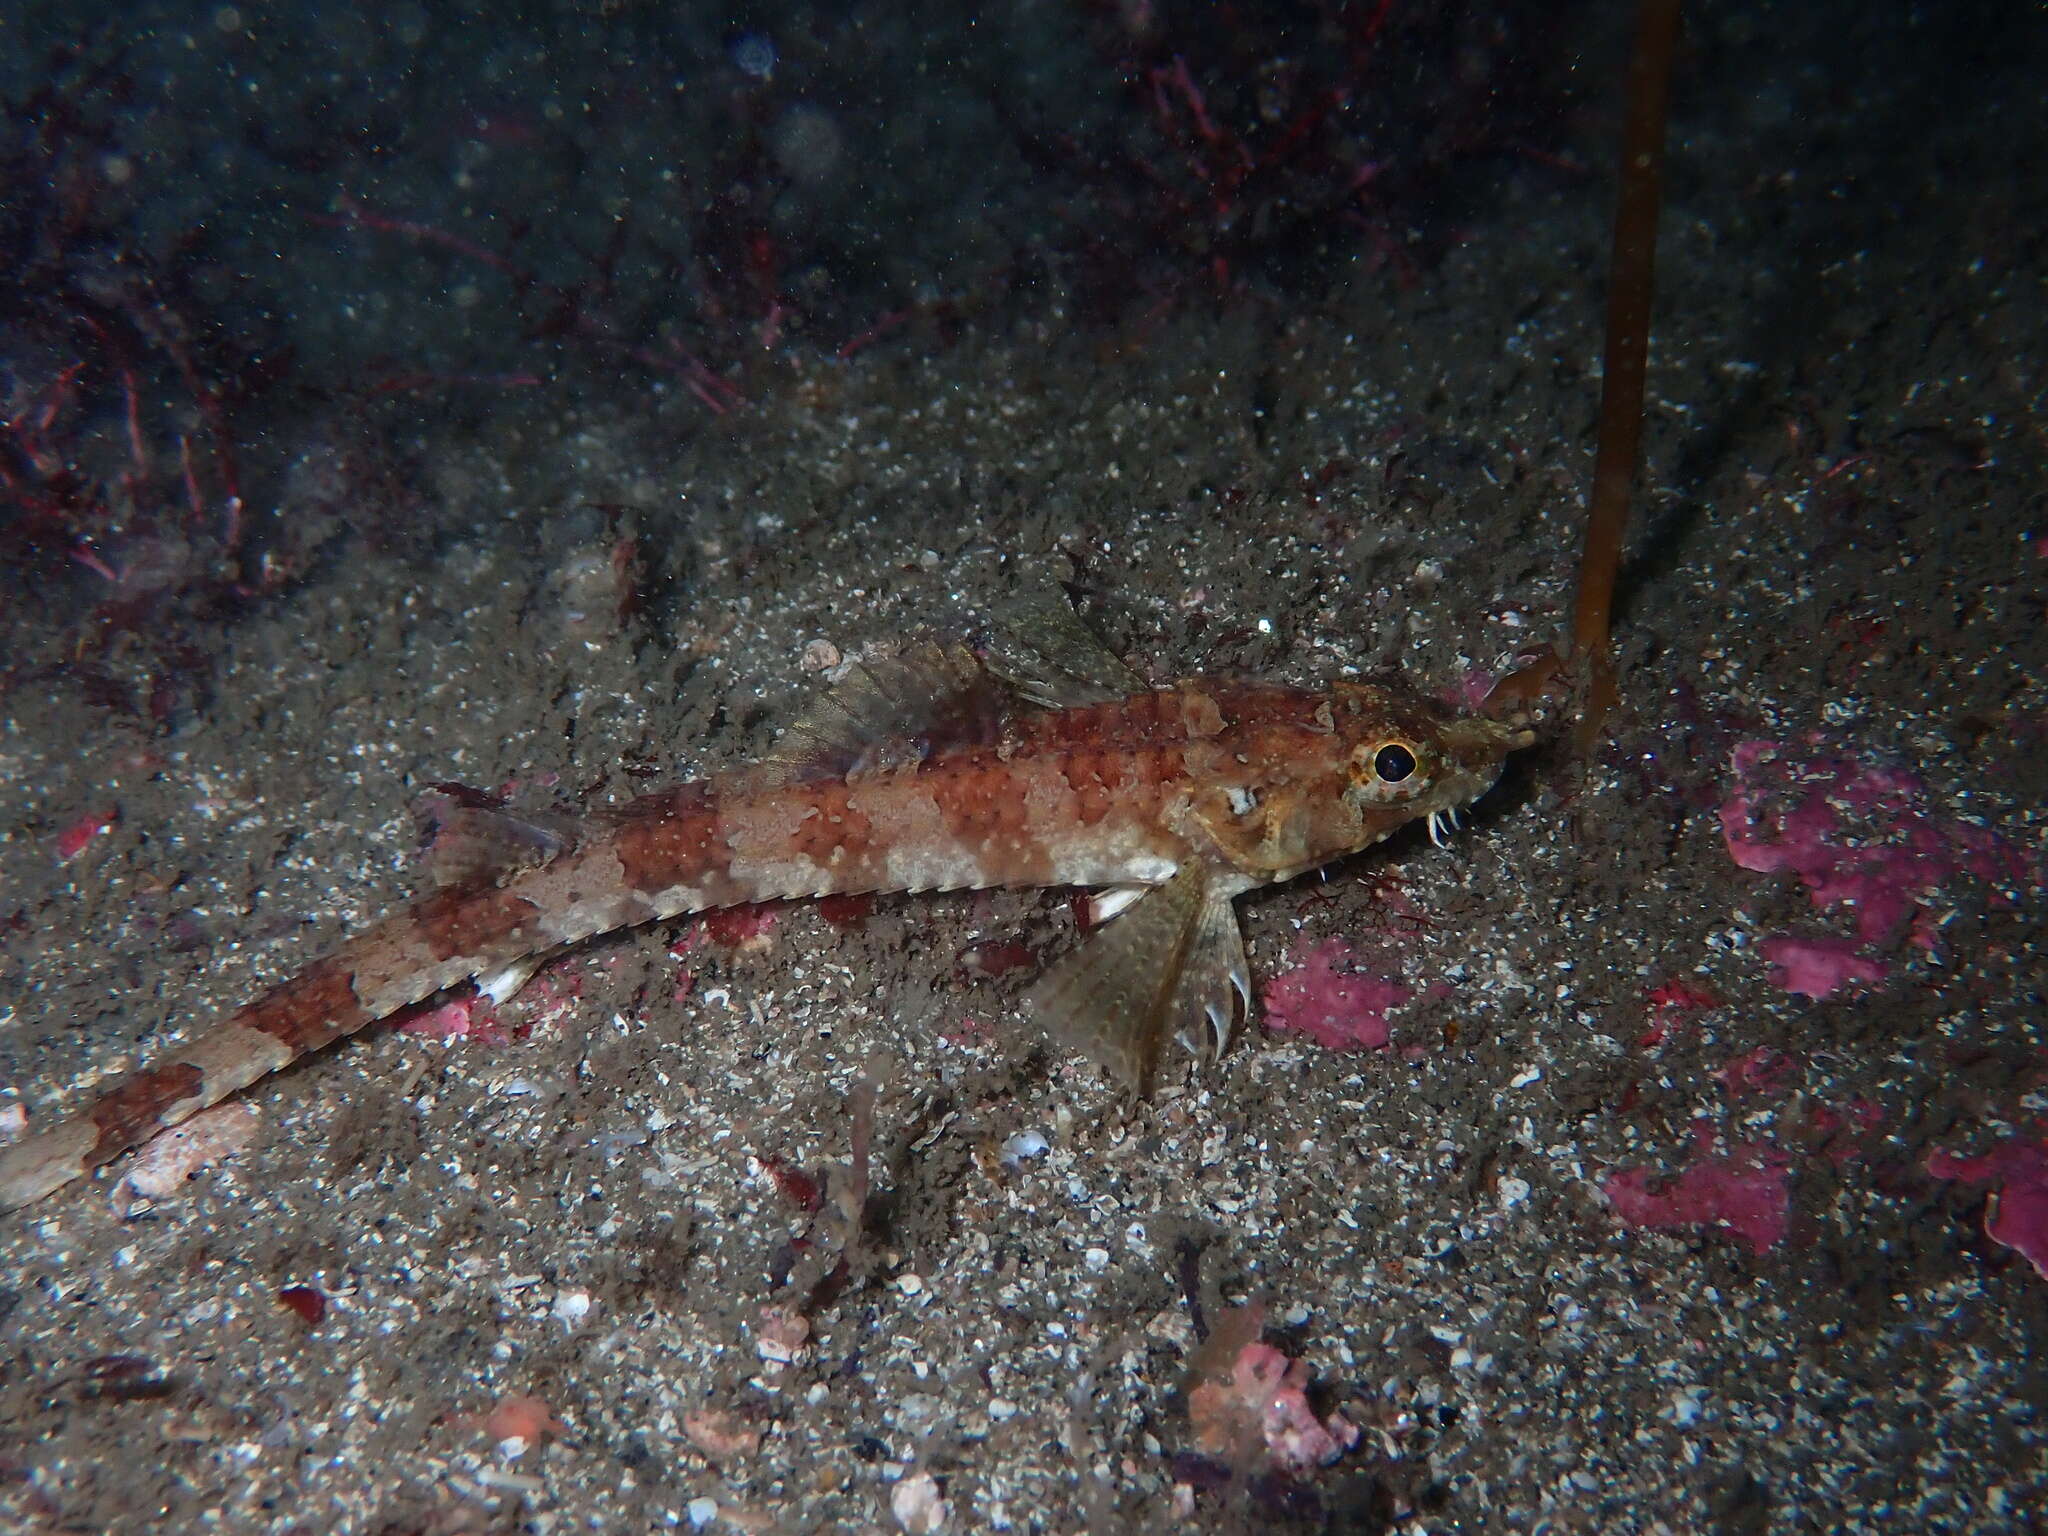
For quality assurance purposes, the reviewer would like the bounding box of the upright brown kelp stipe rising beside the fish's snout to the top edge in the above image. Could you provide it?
[1491,0,1679,754]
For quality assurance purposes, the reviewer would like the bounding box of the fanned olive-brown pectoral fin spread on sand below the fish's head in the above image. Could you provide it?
[1026,862,1251,1094]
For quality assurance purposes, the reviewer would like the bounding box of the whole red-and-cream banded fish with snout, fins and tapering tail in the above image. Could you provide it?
[0,600,1540,1208]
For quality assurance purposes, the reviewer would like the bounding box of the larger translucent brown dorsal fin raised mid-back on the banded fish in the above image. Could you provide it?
[760,641,1018,784]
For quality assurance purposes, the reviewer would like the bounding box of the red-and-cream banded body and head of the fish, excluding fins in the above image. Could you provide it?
[0,666,1540,1206]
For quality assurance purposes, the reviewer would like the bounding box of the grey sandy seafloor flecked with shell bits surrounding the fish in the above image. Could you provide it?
[0,8,2048,1534]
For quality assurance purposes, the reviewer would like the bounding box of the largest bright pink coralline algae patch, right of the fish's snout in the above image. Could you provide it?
[1720,739,2040,999]
